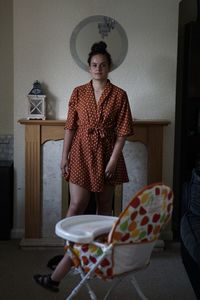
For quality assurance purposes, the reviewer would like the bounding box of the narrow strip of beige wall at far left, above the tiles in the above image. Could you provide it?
[0,0,13,134]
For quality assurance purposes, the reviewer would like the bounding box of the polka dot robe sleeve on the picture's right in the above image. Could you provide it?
[116,92,134,136]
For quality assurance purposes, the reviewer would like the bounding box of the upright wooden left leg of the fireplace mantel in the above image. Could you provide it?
[25,125,41,238]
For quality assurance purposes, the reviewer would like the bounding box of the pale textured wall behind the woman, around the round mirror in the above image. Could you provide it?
[13,0,179,236]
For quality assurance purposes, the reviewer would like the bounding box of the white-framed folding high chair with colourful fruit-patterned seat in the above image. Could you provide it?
[56,183,173,300]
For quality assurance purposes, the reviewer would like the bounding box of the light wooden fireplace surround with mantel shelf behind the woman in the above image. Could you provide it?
[19,119,169,243]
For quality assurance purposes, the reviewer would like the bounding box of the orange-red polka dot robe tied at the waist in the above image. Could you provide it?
[65,80,133,192]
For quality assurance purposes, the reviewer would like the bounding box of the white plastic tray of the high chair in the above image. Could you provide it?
[55,215,118,243]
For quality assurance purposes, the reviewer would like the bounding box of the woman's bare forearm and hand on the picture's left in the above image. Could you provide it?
[60,129,76,176]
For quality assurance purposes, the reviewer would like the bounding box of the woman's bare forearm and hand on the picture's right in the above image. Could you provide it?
[105,136,126,178]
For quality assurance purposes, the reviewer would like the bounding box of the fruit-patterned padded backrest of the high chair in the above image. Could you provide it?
[108,184,173,243]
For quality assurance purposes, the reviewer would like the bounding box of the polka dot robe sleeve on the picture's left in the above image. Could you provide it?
[65,88,78,130]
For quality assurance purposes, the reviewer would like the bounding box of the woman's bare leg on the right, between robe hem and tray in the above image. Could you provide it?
[97,185,114,216]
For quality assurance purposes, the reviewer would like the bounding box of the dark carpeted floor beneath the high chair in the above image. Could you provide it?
[0,240,196,300]
